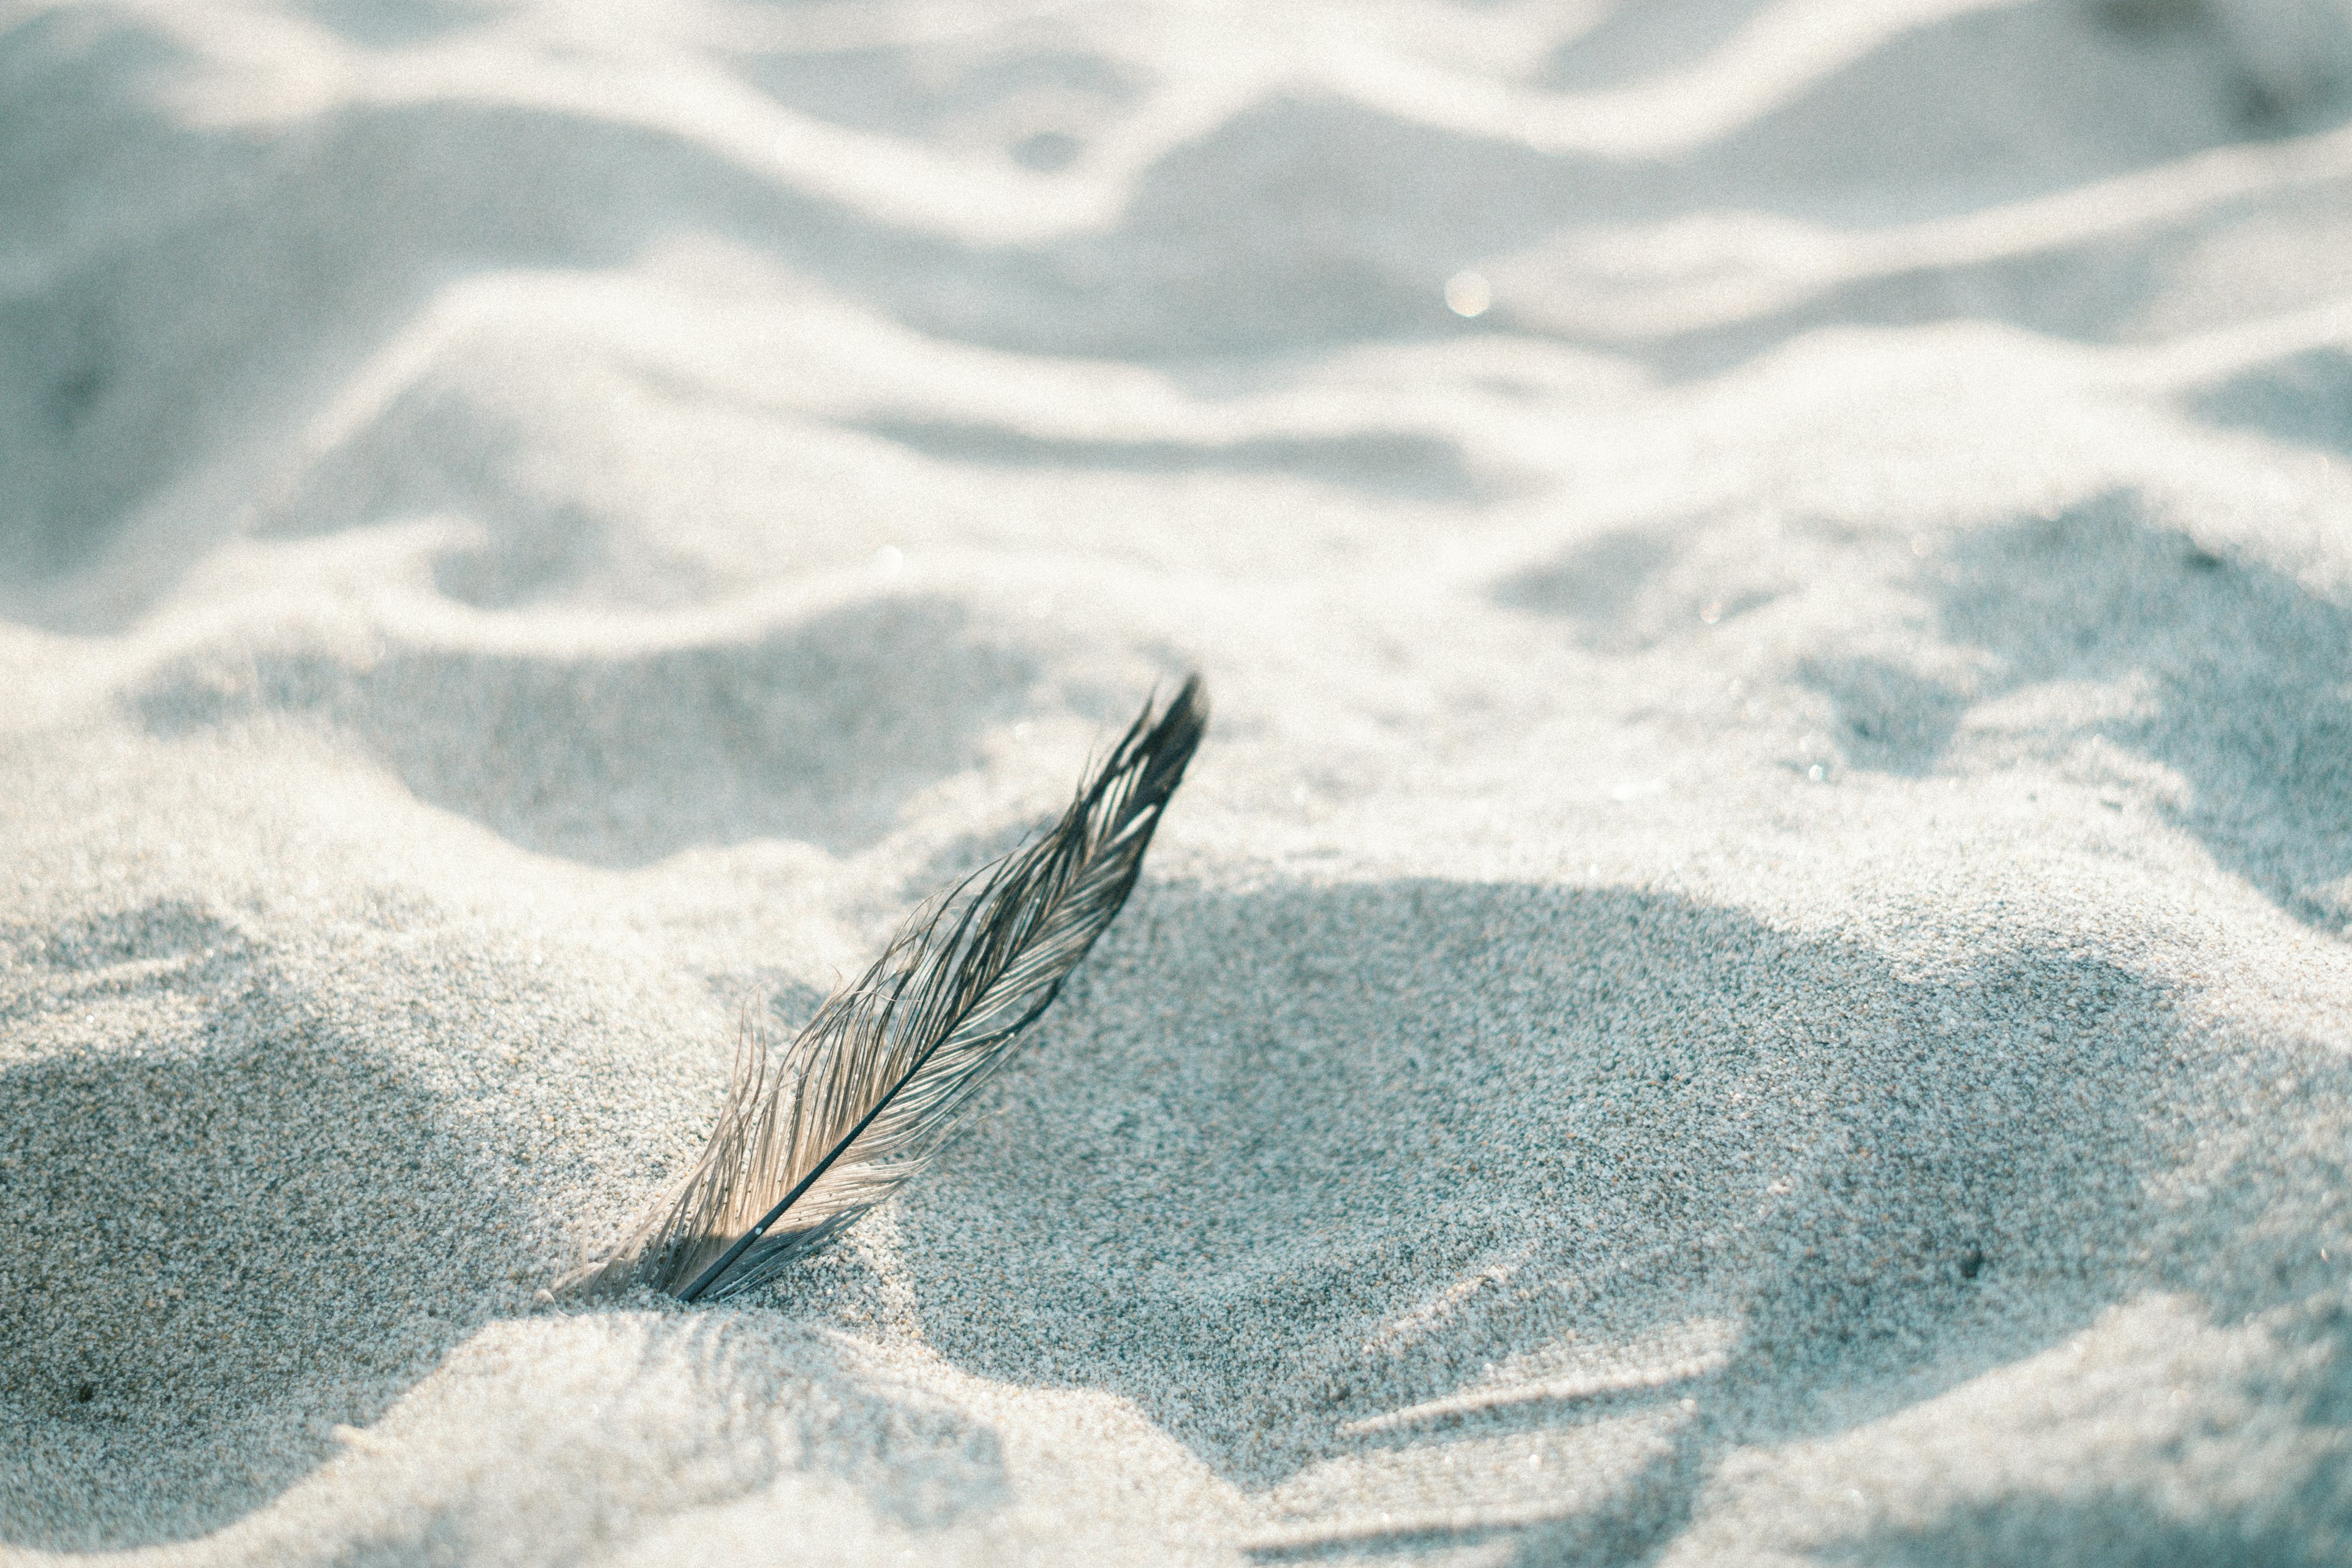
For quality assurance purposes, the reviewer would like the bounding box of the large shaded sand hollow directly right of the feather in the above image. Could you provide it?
[856,881,2316,1563]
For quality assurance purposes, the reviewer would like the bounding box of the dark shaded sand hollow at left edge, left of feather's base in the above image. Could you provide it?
[0,903,527,1549]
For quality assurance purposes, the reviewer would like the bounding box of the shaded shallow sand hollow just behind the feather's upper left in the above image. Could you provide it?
[139,600,1037,867]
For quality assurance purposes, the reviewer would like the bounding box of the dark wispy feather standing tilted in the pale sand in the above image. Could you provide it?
[565,677,1209,1302]
